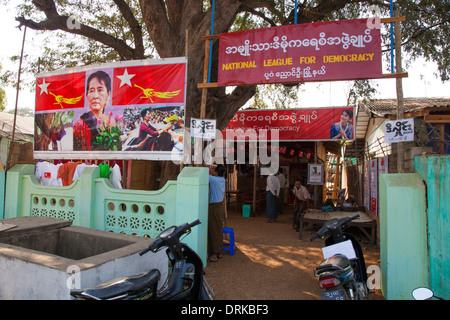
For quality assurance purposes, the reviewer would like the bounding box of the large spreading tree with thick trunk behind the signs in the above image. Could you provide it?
[7,0,450,177]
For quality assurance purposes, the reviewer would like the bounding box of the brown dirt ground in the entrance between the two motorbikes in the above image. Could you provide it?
[205,206,384,300]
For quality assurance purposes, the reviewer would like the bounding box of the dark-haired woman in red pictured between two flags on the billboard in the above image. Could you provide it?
[73,71,115,151]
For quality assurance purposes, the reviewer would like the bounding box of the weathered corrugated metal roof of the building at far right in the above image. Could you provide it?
[358,97,450,117]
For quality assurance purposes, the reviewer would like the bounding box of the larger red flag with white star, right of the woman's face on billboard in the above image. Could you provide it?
[112,63,186,105]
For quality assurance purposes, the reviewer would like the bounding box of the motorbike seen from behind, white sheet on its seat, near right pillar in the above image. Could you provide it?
[310,214,368,300]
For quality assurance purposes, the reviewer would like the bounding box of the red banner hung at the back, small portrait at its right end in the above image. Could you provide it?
[224,107,355,141]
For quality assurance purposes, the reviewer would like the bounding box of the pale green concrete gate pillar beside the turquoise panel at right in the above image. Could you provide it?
[379,173,429,300]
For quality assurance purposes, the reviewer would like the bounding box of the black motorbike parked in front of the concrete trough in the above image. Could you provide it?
[70,220,213,300]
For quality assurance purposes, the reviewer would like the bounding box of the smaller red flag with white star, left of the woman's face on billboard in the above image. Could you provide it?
[36,72,85,111]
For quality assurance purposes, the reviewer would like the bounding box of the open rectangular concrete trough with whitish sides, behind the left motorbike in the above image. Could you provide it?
[0,217,167,300]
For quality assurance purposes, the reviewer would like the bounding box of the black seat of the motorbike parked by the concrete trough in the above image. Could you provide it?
[82,269,161,299]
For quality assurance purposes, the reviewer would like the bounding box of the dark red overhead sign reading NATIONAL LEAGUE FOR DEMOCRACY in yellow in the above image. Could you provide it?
[218,19,382,86]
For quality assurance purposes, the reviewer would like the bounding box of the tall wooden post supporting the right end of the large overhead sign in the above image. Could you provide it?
[394,10,404,173]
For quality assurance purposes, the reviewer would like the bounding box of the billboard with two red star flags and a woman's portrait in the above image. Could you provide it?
[34,58,187,160]
